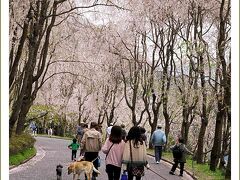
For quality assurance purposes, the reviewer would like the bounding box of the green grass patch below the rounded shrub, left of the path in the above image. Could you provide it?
[9,148,37,166]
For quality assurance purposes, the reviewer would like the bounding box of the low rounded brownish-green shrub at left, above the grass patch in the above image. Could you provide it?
[9,134,36,155]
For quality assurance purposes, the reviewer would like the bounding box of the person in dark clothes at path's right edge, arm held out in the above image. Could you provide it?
[169,137,193,176]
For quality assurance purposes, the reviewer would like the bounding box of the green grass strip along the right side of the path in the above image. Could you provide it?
[147,149,225,180]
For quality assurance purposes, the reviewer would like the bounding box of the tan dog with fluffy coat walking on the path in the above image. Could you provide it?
[68,161,101,180]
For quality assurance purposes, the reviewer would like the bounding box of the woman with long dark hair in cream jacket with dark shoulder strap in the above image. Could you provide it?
[122,126,149,180]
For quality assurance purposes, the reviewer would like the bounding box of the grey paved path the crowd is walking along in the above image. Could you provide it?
[9,137,192,180]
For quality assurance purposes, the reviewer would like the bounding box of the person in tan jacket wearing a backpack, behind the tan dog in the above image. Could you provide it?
[81,122,102,179]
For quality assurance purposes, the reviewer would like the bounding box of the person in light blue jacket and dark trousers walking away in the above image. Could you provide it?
[151,124,166,164]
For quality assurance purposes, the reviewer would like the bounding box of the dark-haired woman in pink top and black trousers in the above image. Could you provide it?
[102,126,125,180]
